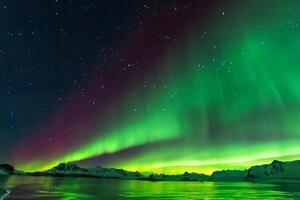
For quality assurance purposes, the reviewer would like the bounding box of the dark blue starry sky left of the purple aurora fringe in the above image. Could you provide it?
[0,0,176,160]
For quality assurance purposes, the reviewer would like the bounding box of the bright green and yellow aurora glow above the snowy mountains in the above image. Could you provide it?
[17,1,300,174]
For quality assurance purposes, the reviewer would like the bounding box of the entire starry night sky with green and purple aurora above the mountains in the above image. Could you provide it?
[0,0,300,174]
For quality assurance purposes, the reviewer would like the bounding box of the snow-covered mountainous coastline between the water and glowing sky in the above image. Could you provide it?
[0,160,300,183]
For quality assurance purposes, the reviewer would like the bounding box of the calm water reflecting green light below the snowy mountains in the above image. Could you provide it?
[0,176,300,200]
